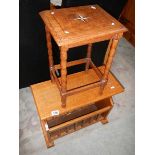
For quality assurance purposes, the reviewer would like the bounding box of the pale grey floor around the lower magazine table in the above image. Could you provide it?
[19,38,135,155]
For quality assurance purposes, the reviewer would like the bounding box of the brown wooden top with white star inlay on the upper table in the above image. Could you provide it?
[39,5,127,47]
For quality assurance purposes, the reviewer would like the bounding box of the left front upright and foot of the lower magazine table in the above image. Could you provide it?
[40,120,54,147]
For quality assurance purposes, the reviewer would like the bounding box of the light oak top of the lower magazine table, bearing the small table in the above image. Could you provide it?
[31,67,124,120]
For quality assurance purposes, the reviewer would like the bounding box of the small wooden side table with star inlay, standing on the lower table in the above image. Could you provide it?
[40,5,127,107]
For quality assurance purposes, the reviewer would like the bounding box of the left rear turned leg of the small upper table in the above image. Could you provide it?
[45,26,54,81]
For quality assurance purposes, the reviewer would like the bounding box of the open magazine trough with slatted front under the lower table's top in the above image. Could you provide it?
[46,98,113,147]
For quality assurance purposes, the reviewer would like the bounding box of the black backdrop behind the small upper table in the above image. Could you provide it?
[19,0,127,88]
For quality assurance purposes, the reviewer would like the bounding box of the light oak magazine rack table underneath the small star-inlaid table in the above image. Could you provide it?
[31,75,119,147]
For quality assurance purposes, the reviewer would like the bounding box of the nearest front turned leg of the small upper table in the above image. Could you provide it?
[60,47,68,107]
